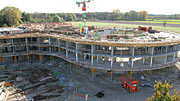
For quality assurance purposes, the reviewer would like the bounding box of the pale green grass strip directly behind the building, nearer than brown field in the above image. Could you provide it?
[72,22,180,33]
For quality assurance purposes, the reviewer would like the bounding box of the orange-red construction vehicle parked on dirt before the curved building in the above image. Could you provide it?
[120,75,139,92]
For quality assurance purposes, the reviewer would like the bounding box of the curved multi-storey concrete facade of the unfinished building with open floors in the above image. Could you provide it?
[0,26,180,72]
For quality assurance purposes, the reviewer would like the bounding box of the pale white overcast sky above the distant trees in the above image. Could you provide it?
[0,0,180,14]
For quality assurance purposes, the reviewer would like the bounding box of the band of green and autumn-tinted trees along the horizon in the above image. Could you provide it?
[0,6,180,26]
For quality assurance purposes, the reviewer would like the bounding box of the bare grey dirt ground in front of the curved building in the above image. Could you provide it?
[2,58,180,101]
